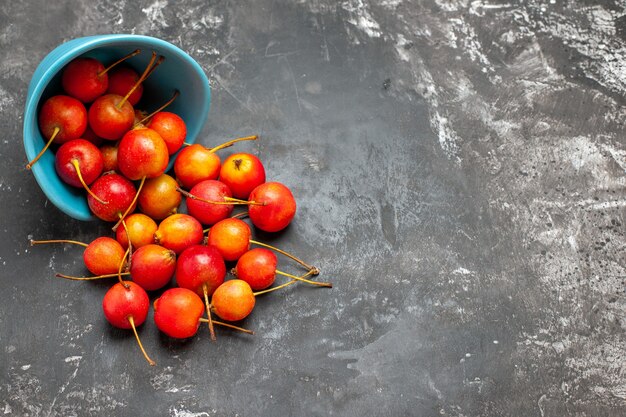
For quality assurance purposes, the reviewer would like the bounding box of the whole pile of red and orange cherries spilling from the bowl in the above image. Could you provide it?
[27,50,332,365]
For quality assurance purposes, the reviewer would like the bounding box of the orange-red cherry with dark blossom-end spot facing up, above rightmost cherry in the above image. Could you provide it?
[220,153,265,198]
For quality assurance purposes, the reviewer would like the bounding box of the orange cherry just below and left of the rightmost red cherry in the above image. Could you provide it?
[207,217,252,261]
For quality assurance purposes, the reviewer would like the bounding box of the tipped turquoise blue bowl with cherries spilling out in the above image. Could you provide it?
[24,35,211,220]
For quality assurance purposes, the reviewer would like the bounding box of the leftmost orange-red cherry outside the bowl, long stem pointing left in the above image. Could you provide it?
[30,236,124,275]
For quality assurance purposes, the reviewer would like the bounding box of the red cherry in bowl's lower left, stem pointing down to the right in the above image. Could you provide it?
[54,139,104,203]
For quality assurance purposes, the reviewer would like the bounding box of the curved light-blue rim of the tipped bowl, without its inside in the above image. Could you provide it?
[22,34,211,220]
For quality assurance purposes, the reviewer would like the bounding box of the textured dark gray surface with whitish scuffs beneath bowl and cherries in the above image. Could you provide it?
[0,0,626,417]
